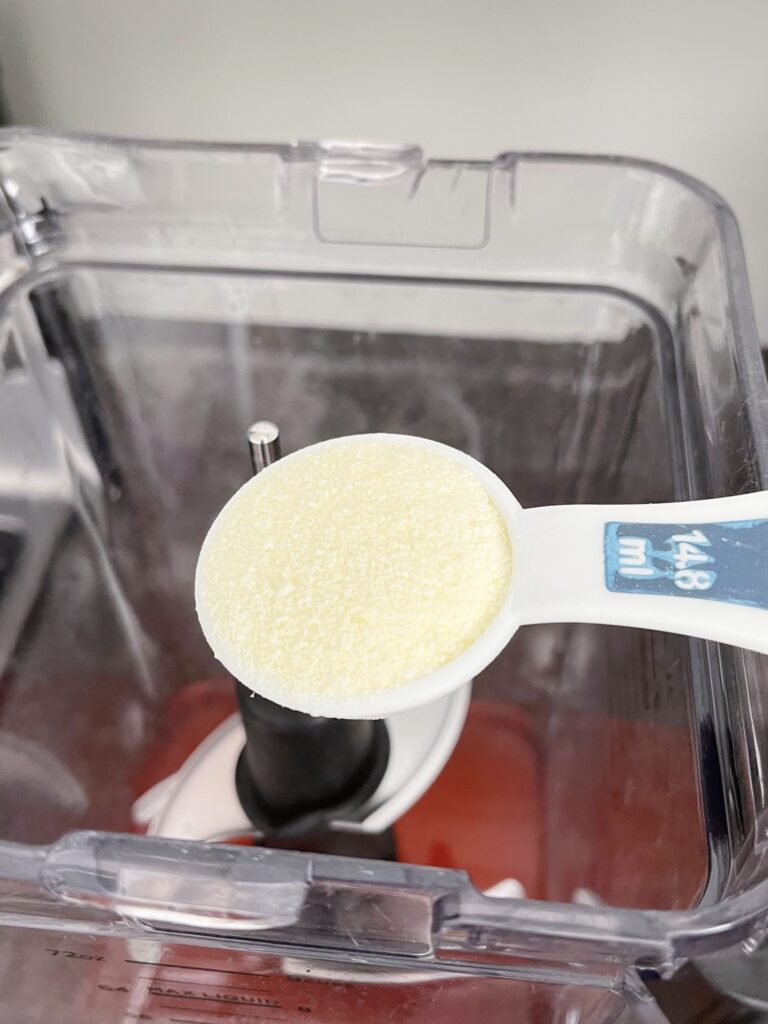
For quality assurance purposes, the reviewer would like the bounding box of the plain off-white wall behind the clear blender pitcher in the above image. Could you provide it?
[0,0,768,340]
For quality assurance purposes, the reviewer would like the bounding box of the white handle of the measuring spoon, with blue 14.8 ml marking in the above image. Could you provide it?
[514,492,768,653]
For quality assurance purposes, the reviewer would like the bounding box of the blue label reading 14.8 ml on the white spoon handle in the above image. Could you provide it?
[603,519,768,608]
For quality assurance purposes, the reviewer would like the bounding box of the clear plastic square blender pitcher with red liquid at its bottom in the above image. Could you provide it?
[0,131,768,1024]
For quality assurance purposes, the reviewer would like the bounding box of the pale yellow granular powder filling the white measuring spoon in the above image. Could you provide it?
[196,440,512,699]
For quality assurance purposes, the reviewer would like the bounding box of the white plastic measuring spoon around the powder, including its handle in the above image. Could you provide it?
[198,434,768,718]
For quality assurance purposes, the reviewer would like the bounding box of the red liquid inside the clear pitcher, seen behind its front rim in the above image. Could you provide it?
[131,679,707,908]
